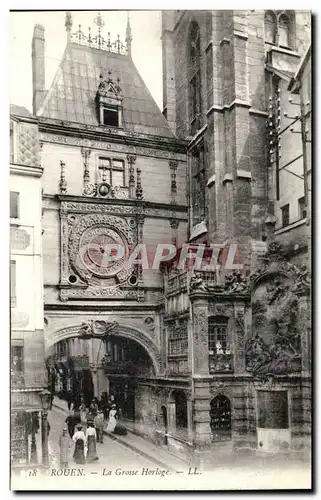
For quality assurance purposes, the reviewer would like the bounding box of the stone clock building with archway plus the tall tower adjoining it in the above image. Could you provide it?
[10,11,311,466]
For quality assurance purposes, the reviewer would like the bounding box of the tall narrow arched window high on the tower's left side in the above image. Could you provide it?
[188,21,202,135]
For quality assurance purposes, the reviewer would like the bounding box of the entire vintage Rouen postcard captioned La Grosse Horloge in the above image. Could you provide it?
[9,10,313,491]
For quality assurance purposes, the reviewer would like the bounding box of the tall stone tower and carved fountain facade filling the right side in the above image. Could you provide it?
[162,10,311,460]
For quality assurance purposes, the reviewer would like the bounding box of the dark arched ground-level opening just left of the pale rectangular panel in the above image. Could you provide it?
[210,395,232,441]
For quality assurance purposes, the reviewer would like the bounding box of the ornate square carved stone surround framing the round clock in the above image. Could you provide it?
[60,201,143,301]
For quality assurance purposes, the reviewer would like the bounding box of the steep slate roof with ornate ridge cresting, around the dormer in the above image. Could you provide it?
[37,42,175,138]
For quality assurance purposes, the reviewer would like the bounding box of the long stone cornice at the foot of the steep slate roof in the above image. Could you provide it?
[39,118,187,154]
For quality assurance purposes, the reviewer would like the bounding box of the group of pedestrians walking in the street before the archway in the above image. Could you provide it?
[59,398,127,468]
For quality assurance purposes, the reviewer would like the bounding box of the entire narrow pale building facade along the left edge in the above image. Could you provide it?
[10,106,45,467]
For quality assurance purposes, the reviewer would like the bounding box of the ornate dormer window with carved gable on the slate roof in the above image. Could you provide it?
[96,71,123,127]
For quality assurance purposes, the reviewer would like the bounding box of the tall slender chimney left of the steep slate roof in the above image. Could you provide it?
[32,24,46,115]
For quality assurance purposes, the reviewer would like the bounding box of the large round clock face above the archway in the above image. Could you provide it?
[80,226,128,278]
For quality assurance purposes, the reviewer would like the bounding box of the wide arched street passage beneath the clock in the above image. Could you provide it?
[47,321,160,420]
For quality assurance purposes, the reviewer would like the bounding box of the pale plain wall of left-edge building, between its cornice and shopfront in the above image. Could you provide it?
[10,158,44,387]
